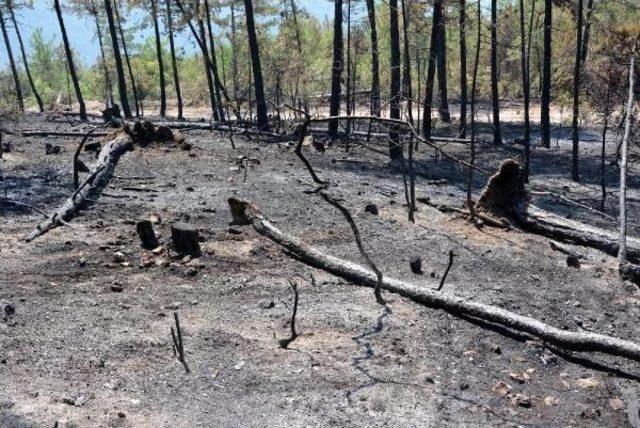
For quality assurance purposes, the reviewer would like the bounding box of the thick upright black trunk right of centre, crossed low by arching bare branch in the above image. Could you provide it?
[389,0,402,160]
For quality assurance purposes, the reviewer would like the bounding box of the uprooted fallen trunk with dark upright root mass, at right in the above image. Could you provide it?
[476,160,640,263]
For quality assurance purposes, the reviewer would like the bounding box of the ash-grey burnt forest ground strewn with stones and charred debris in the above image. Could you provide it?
[0,116,640,427]
